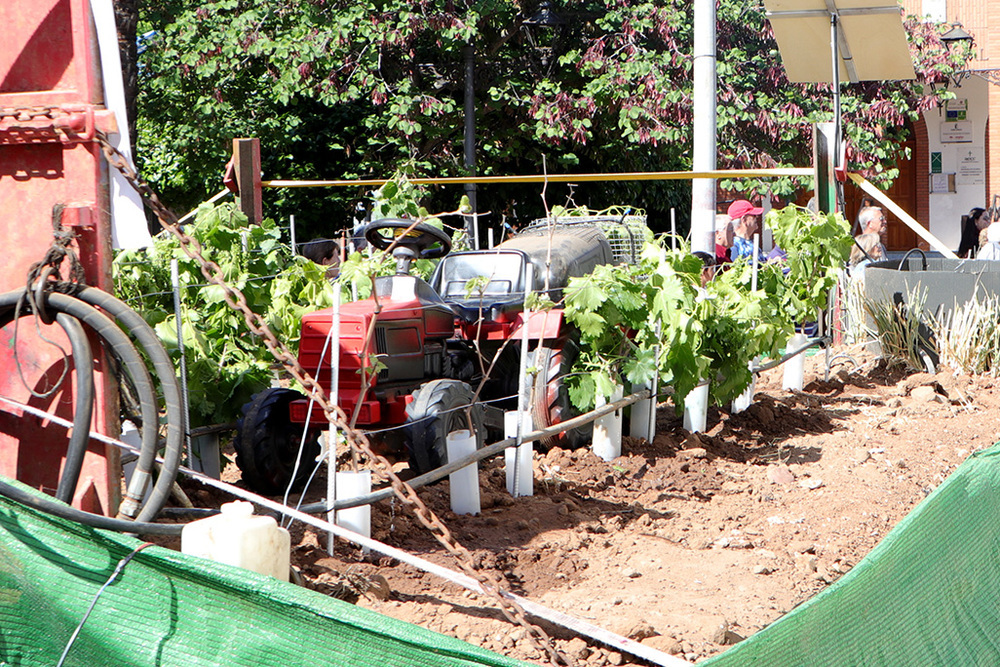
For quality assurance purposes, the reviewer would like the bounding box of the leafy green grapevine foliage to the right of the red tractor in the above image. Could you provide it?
[565,207,851,409]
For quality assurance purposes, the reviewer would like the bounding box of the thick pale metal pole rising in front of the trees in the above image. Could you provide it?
[691,0,716,253]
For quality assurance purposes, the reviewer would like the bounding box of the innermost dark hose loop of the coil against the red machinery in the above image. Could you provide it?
[56,313,94,503]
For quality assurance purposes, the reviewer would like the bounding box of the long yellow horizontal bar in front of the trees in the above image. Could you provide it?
[261,167,813,188]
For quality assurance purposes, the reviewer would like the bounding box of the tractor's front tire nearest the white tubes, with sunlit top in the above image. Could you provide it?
[406,379,486,475]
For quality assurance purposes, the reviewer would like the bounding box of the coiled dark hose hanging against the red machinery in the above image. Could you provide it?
[0,282,185,534]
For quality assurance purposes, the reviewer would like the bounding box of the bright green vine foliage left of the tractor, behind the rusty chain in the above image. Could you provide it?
[114,204,333,426]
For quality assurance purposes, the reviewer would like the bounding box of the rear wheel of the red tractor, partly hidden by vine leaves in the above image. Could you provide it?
[531,338,594,451]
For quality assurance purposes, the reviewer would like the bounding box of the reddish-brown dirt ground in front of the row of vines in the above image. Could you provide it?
[178,348,1000,666]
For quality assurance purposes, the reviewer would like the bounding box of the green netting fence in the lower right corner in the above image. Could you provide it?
[699,445,1000,667]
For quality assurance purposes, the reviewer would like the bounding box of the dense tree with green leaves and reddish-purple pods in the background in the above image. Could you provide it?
[139,0,972,240]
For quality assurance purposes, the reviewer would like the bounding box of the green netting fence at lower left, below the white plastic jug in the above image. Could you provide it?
[0,480,525,667]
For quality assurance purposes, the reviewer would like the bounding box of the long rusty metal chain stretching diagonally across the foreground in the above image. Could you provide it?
[96,132,570,665]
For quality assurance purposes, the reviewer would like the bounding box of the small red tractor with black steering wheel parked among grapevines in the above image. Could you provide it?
[234,218,644,493]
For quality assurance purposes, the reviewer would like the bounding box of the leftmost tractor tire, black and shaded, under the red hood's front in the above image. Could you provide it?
[233,387,320,495]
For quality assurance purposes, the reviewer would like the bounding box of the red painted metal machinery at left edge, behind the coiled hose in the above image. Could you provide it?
[0,0,120,514]
